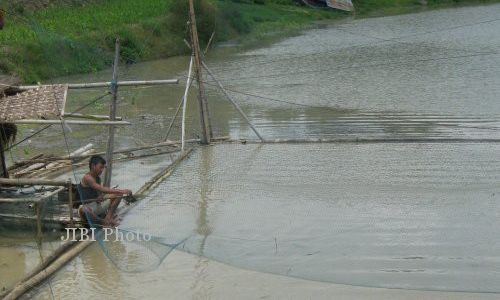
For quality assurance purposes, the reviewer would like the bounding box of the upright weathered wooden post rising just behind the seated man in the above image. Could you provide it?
[104,38,120,187]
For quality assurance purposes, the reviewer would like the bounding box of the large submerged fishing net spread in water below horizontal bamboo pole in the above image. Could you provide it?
[98,144,500,292]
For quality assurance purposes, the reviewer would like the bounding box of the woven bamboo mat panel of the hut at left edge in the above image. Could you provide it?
[0,85,68,123]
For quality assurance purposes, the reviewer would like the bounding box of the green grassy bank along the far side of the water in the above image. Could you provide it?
[0,0,498,83]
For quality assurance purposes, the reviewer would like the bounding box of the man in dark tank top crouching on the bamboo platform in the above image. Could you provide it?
[78,155,132,226]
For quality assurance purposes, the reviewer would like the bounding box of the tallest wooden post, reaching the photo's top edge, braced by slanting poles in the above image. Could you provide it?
[189,0,212,144]
